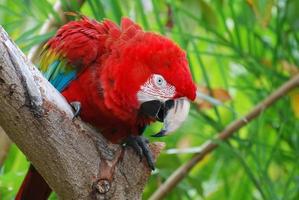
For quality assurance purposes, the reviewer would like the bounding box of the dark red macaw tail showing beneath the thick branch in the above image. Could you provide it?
[15,164,52,200]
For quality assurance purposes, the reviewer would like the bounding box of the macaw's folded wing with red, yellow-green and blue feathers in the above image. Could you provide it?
[39,17,120,92]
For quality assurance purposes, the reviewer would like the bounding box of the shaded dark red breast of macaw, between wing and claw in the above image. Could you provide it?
[62,68,143,143]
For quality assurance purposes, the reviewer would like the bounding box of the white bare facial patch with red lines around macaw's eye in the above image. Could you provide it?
[137,74,176,103]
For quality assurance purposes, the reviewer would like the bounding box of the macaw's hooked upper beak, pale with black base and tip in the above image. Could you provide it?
[152,98,190,137]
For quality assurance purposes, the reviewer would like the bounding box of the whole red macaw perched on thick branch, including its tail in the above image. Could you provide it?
[16,16,217,200]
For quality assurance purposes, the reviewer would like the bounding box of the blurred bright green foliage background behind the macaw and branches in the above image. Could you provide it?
[0,0,299,200]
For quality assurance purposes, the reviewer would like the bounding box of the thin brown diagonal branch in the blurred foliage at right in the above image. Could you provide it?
[150,75,299,200]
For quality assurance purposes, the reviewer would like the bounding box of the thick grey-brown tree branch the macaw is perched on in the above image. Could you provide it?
[0,27,161,199]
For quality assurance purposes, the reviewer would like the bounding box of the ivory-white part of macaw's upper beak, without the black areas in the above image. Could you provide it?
[160,97,190,135]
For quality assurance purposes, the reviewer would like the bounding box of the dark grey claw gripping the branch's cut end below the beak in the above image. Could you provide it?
[125,135,155,170]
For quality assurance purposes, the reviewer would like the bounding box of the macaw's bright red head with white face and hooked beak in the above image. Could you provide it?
[102,18,196,136]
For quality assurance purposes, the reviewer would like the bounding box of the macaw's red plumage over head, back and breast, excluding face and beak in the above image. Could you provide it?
[42,18,195,143]
